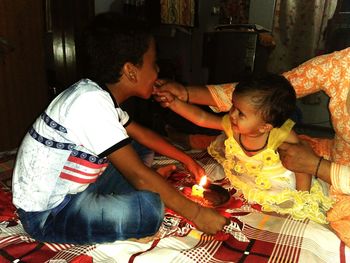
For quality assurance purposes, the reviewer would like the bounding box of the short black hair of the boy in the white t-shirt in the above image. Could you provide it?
[83,12,152,84]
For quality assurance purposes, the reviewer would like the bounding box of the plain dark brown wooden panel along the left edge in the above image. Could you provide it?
[0,0,49,152]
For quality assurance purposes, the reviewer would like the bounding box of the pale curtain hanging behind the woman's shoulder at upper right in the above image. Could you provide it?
[268,0,337,73]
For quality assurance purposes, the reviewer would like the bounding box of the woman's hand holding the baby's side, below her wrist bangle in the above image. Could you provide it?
[278,141,320,174]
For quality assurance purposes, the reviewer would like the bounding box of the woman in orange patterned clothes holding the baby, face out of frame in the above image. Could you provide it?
[154,48,350,245]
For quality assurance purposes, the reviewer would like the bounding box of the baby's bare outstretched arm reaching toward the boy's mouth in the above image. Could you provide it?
[160,92,223,130]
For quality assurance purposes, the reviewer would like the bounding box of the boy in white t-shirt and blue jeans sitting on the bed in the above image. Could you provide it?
[13,13,226,244]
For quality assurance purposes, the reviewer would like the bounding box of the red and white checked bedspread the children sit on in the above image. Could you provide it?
[0,151,350,263]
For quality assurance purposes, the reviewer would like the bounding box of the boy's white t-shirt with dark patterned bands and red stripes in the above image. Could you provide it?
[13,79,130,212]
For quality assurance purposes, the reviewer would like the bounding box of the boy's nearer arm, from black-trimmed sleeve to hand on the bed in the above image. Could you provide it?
[108,145,226,234]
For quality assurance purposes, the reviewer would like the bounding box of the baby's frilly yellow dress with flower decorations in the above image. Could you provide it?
[208,115,333,223]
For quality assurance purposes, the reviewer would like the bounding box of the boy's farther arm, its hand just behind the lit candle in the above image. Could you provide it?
[126,121,205,180]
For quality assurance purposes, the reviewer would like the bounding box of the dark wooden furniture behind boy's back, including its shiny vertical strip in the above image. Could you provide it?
[0,0,94,152]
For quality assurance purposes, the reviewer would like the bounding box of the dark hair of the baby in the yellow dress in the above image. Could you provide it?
[234,73,296,127]
